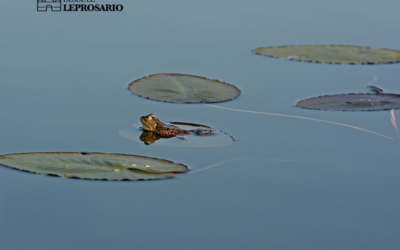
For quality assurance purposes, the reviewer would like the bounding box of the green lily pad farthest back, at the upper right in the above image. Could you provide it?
[254,45,400,64]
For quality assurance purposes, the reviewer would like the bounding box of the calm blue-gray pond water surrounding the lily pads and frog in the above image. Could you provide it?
[0,0,400,250]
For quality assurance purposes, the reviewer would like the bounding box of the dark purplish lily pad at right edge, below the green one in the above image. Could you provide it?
[297,93,400,111]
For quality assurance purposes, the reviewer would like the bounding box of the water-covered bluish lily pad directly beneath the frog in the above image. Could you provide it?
[119,122,234,147]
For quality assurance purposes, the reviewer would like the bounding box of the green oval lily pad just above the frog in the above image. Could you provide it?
[129,74,240,103]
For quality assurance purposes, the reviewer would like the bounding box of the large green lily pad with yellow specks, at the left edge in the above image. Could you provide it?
[0,152,189,180]
